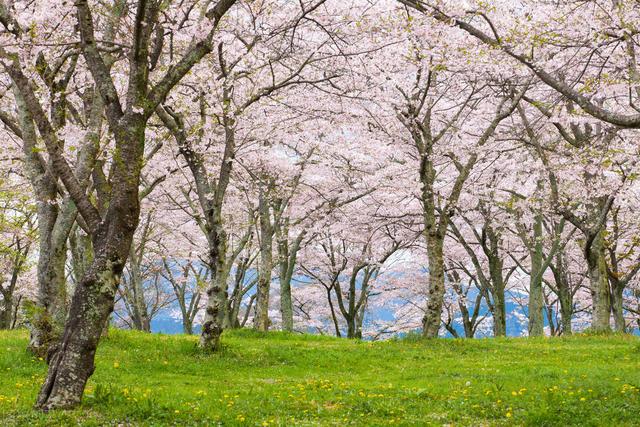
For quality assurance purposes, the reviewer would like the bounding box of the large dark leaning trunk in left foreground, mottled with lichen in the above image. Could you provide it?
[37,116,145,411]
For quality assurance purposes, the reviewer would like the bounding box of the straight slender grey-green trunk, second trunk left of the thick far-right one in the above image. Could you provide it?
[529,215,544,337]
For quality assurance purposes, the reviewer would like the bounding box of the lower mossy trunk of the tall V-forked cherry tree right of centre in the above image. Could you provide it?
[422,236,445,338]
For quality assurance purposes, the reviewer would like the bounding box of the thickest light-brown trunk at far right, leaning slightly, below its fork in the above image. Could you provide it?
[584,231,611,332]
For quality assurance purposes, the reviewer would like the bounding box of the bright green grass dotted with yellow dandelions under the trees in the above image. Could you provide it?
[0,330,640,426]
